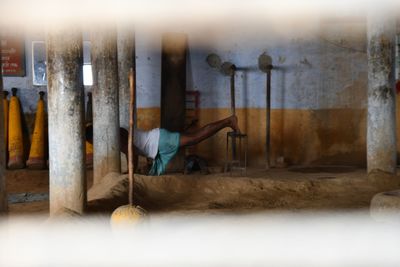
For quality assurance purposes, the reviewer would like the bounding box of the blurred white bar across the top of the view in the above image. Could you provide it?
[0,0,400,29]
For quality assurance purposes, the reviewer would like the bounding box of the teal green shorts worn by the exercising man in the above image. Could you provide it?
[149,129,180,175]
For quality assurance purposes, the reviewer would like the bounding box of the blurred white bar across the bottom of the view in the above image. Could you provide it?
[0,213,400,267]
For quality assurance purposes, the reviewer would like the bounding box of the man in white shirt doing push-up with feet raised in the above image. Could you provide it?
[86,116,240,175]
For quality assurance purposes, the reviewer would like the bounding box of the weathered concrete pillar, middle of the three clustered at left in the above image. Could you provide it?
[91,29,121,183]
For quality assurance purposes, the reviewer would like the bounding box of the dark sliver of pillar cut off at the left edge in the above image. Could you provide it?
[0,49,7,214]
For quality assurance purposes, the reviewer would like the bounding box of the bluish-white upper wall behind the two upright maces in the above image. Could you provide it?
[188,21,367,109]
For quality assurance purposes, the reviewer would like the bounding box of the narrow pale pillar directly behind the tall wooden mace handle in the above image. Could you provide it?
[118,27,136,129]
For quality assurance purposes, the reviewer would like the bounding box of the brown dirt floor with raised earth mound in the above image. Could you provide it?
[6,166,399,217]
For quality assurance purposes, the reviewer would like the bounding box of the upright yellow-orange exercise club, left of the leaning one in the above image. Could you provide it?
[8,88,24,169]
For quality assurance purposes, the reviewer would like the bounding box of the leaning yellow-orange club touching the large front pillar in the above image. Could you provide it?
[26,92,46,169]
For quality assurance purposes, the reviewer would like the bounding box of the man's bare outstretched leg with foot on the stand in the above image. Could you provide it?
[179,116,240,147]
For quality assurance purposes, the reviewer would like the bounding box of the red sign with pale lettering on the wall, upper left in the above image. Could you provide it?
[0,36,25,76]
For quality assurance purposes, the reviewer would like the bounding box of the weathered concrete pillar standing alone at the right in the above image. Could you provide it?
[367,12,396,173]
